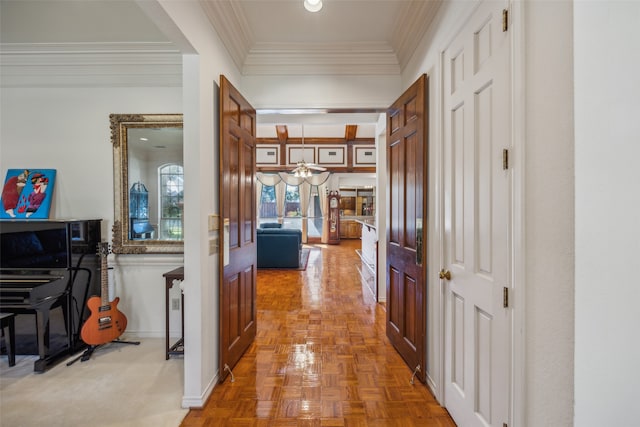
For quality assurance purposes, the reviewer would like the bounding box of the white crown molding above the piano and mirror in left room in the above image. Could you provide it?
[0,43,182,87]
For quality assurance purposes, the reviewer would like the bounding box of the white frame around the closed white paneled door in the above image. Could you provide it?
[428,1,526,427]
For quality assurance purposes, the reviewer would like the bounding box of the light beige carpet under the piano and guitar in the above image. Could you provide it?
[0,338,188,427]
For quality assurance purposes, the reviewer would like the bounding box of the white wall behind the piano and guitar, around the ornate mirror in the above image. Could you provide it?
[0,87,182,337]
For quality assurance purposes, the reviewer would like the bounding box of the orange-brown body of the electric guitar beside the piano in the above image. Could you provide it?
[80,297,127,345]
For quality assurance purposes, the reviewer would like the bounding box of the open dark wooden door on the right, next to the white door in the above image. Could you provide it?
[387,75,428,382]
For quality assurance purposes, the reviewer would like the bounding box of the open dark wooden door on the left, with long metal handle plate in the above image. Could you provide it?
[219,76,257,381]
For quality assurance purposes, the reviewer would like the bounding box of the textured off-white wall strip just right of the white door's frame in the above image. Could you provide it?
[516,2,574,426]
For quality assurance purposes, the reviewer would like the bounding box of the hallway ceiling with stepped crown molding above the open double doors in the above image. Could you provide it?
[201,0,440,75]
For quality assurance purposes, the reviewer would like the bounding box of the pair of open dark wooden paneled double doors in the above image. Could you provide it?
[219,75,427,381]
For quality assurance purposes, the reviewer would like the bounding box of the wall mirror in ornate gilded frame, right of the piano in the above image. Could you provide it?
[109,114,184,254]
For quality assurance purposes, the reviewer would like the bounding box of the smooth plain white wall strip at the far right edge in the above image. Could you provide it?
[574,1,640,427]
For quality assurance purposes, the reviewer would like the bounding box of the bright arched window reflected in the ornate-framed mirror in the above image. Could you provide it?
[158,164,184,240]
